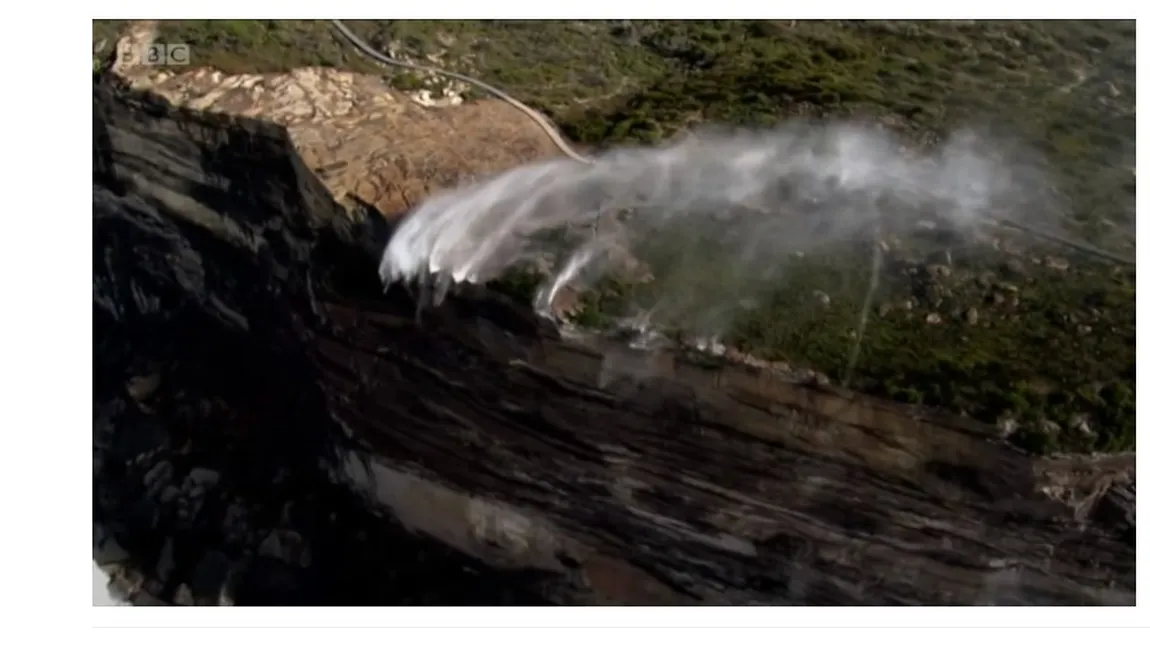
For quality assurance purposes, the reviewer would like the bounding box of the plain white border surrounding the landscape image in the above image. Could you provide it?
[0,0,1150,647]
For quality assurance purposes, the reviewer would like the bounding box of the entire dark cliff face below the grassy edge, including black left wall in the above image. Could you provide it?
[93,75,1134,604]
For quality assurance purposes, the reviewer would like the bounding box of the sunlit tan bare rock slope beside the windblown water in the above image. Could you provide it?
[113,21,559,215]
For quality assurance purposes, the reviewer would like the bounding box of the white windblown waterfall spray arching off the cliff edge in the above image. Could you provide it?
[380,124,1045,358]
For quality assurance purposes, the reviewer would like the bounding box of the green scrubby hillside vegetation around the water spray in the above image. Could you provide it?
[93,21,1135,450]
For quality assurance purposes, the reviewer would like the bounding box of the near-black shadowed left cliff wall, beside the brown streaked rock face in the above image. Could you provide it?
[93,76,549,604]
